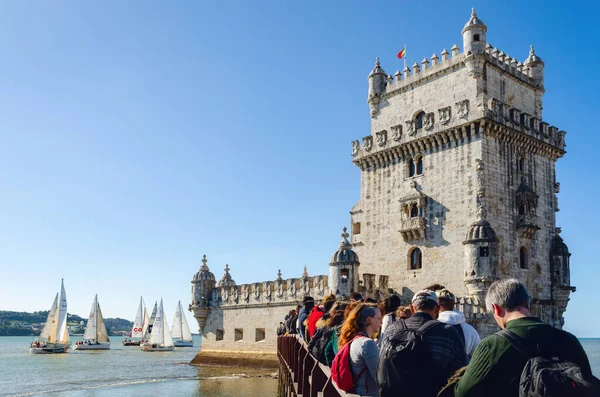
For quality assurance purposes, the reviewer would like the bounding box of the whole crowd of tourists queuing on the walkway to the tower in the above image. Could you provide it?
[277,279,600,397]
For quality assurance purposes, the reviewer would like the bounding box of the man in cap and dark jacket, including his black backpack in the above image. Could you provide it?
[377,290,467,397]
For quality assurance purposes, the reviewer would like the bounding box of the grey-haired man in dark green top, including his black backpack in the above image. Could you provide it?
[454,279,600,397]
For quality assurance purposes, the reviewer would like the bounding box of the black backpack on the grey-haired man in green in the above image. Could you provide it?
[496,329,600,397]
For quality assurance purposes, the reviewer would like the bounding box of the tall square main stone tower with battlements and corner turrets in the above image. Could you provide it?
[350,10,575,334]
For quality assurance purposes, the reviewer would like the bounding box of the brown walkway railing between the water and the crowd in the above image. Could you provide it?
[277,335,360,397]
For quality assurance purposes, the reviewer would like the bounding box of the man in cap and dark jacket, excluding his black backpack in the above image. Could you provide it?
[379,290,468,397]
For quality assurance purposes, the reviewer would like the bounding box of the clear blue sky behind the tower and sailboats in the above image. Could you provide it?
[0,0,600,337]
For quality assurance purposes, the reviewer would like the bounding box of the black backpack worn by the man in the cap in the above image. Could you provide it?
[377,320,442,397]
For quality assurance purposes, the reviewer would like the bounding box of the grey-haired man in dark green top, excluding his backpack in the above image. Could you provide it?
[454,279,592,397]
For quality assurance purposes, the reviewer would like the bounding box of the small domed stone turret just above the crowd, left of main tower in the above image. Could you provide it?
[329,227,360,298]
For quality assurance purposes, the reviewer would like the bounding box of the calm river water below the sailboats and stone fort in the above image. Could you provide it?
[0,336,277,397]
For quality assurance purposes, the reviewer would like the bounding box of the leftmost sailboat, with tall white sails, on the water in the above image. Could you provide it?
[29,280,70,354]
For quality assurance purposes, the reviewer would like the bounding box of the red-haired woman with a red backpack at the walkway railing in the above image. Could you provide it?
[331,303,381,397]
